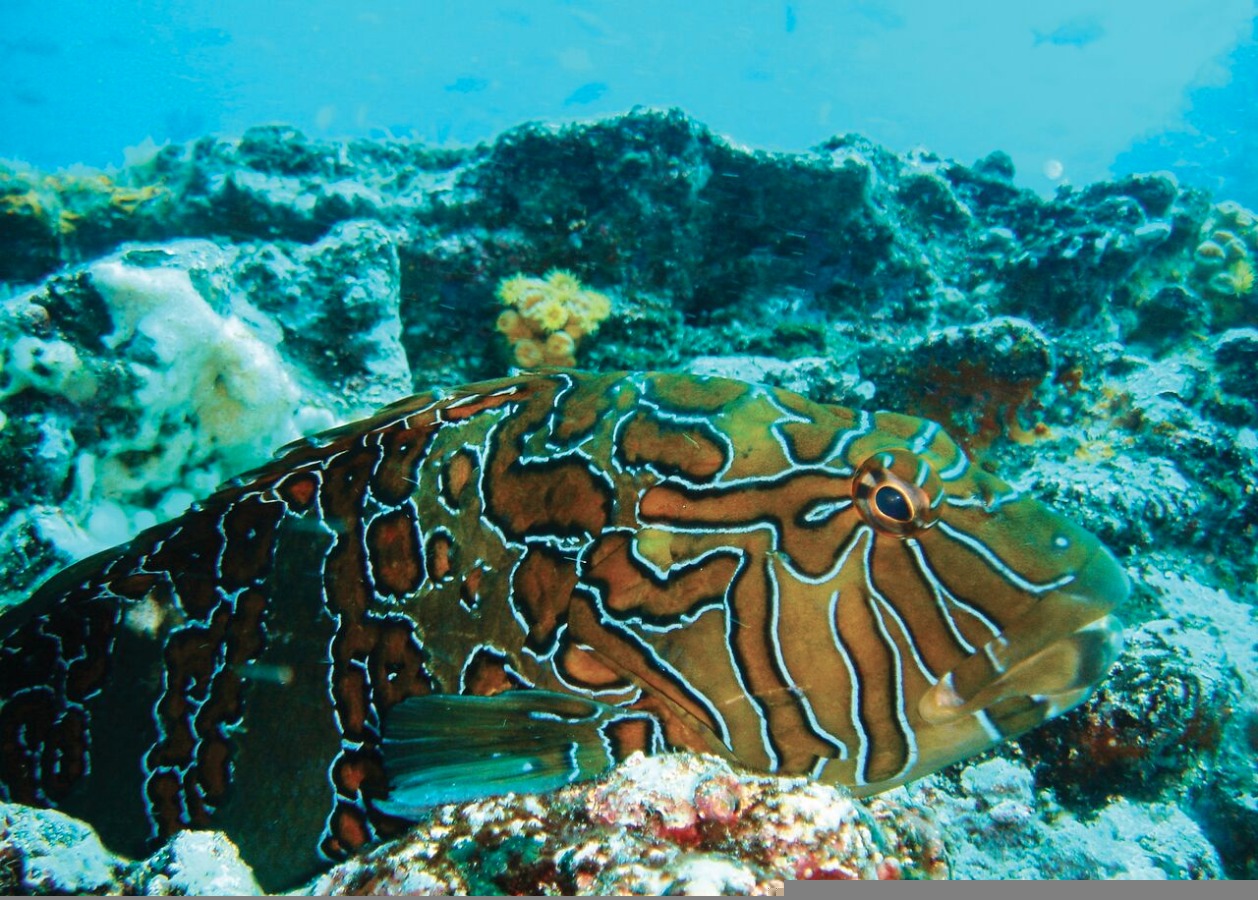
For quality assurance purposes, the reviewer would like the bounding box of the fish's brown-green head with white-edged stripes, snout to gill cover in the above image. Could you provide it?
[629,390,1127,793]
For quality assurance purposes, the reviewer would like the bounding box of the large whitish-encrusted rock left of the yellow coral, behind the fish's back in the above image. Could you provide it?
[0,234,411,611]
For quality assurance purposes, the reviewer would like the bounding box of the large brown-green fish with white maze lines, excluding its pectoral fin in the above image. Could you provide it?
[0,371,1127,885]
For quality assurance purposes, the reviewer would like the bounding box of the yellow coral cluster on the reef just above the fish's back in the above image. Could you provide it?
[496,269,611,369]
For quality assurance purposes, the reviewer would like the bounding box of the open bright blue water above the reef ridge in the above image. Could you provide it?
[0,0,1258,205]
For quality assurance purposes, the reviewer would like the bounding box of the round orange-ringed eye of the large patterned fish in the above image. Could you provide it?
[852,449,942,537]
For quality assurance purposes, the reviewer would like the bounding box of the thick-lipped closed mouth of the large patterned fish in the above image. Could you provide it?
[918,546,1130,736]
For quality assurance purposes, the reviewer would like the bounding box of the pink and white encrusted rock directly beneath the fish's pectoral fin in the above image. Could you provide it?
[311,755,947,896]
